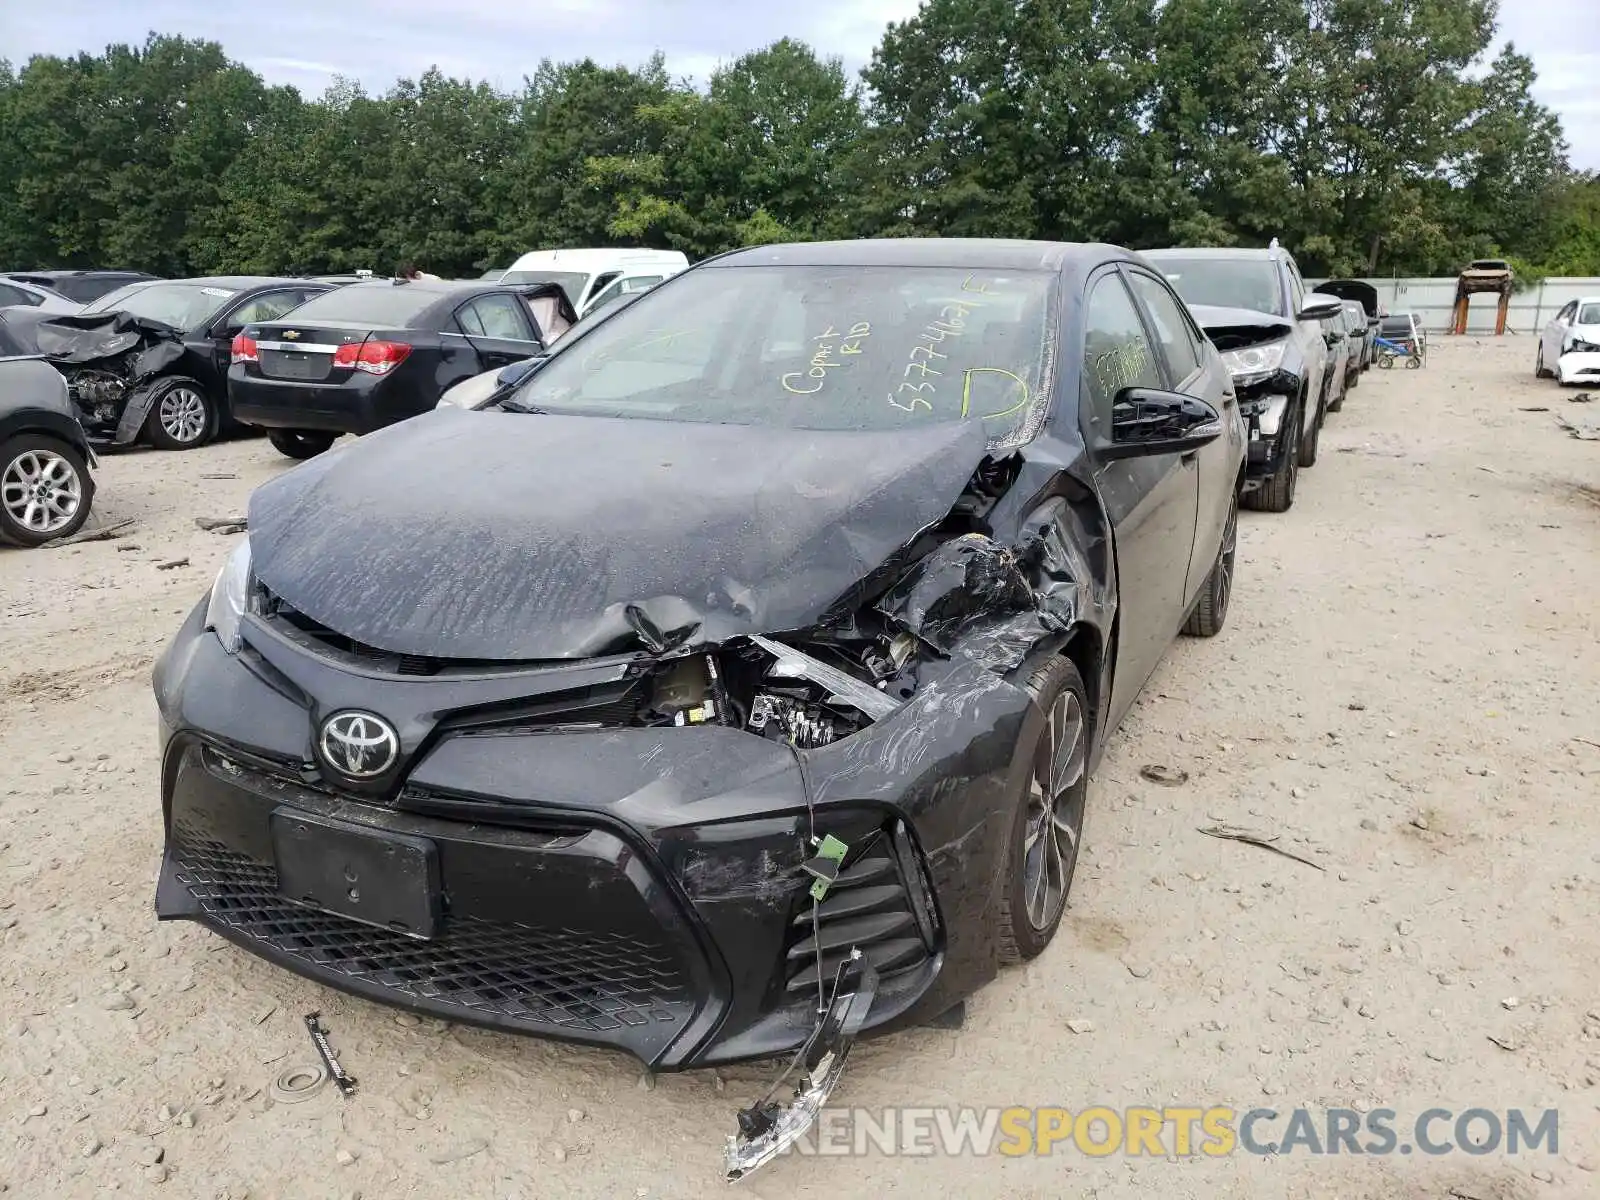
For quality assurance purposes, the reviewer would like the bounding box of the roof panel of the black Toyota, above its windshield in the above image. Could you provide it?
[706,237,1134,270]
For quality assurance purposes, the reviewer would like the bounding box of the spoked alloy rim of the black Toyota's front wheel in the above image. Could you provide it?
[1022,691,1088,930]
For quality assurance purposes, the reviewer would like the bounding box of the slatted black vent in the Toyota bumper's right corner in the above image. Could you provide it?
[784,824,938,992]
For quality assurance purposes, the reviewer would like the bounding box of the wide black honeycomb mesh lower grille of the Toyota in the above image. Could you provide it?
[171,826,696,1042]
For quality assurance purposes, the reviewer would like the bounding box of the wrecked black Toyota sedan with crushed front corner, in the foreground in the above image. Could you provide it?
[154,240,1245,1174]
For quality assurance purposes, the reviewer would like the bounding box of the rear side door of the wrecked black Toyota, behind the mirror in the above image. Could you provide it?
[1123,267,1245,611]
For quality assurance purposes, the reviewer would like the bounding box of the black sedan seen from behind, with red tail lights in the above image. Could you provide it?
[227,278,576,458]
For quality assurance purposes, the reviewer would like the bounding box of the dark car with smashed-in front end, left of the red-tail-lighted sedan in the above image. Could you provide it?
[29,275,334,450]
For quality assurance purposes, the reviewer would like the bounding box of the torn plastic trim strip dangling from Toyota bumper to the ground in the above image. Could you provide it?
[725,950,878,1182]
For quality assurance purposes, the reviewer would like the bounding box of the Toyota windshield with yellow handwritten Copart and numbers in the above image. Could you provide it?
[515,266,1056,446]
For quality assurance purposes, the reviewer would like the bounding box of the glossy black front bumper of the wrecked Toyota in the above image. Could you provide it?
[155,610,1040,1070]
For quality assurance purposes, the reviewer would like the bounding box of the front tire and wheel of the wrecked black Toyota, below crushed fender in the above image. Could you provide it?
[1000,656,1093,963]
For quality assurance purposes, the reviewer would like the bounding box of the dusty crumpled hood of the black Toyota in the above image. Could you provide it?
[250,408,984,661]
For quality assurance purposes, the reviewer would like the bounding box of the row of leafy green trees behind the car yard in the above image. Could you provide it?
[0,0,1600,275]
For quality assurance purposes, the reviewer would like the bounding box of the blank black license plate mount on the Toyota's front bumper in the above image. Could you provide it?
[269,808,442,938]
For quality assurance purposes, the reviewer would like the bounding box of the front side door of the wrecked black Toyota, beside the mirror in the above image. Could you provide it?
[1080,266,1200,728]
